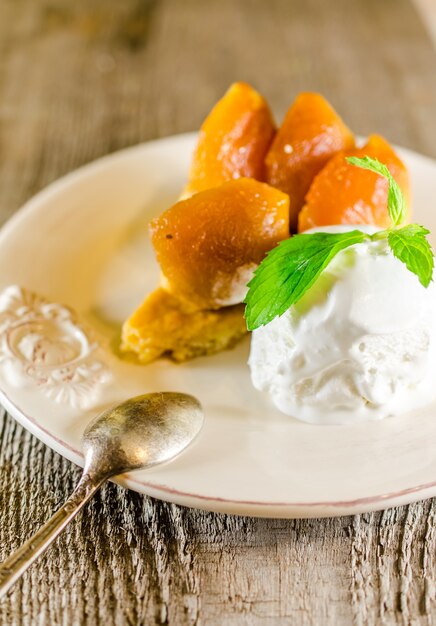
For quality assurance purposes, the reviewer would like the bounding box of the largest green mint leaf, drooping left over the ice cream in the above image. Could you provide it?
[245,230,369,330]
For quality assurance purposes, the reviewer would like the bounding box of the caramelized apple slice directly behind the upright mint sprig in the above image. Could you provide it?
[298,135,409,232]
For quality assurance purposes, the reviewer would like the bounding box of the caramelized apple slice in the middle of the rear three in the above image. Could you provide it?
[266,93,354,232]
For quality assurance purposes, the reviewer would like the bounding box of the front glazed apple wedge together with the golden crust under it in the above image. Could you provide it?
[121,178,289,362]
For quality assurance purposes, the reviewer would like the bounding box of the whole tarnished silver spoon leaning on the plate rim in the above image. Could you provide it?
[0,392,203,598]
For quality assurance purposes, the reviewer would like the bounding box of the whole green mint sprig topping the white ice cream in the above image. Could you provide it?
[245,156,434,330]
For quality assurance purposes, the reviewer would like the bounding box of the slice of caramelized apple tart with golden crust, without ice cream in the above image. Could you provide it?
[121,83,408,363]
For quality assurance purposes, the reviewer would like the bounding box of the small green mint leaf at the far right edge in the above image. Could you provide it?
[388,224,434,287]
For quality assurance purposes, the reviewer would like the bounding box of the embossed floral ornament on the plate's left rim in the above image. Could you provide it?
[0,285,112,408]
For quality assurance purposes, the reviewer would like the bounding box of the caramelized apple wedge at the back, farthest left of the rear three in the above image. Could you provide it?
[185,83,275,195]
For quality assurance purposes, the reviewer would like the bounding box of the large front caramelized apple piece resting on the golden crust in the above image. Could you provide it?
[150,178,289,309]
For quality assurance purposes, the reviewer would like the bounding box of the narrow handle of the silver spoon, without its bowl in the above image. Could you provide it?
[0,473,103,598]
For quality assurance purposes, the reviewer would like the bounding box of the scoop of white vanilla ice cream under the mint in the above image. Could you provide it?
[249,226,436,424]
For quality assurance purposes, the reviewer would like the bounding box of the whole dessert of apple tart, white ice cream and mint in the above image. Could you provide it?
[122,83,436,423]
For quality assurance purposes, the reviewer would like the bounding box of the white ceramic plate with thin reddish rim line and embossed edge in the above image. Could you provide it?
[0,135,436,517]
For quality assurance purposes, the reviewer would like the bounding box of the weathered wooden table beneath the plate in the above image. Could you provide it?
[0,0,436,626]
